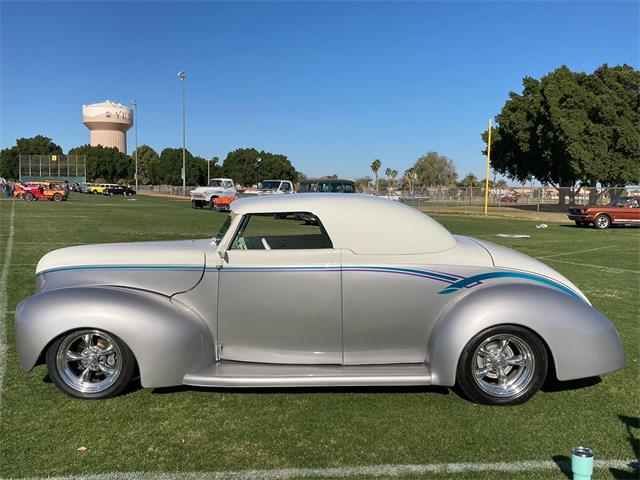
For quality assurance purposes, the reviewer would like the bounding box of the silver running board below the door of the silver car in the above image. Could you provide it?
[183,360,431,388]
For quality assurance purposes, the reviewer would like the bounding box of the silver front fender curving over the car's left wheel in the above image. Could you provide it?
[16,287,215,387]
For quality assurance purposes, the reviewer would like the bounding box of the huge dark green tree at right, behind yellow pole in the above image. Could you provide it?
[483,65,640,202]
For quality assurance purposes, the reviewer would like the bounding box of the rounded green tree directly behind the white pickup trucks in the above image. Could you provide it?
[222,148,298,185]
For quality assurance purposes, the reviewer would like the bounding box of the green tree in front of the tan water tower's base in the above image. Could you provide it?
[68,145,134,183]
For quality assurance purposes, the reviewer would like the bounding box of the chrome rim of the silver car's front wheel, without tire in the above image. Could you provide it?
[56,329,123,393]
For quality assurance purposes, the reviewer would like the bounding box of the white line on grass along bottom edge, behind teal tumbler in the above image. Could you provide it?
[5,460,637,480]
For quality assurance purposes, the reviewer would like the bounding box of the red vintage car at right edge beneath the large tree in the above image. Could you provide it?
[568,195,640,229]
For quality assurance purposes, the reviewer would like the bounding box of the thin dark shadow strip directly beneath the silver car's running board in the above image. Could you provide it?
[152,385,449,395]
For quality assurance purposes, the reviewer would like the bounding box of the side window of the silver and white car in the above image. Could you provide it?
[230,212,333,250]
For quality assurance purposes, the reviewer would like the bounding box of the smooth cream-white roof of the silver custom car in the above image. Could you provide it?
[231,193,457,255]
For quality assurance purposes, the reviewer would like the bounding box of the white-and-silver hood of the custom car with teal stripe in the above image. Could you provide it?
[36,240,210,295]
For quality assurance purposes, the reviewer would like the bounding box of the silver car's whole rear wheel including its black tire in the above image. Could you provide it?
[456,325,548,405]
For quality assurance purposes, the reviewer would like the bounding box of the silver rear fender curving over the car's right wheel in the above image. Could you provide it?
[428,283,624,386]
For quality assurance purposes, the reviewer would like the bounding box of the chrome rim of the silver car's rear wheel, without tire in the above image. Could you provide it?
[471,334,536,398]
